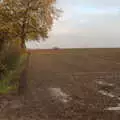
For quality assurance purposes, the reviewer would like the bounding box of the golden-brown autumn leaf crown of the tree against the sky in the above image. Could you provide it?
[0,0,59,48]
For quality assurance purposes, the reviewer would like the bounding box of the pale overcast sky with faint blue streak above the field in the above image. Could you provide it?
[27,0,120,48]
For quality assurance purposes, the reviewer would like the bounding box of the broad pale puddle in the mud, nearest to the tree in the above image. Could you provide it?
[49,88,71,103]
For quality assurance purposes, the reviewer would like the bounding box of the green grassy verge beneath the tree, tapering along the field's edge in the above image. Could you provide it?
[0,52,28,94]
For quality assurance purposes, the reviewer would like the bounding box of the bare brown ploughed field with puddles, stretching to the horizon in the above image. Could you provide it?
[0,49,120,120]
